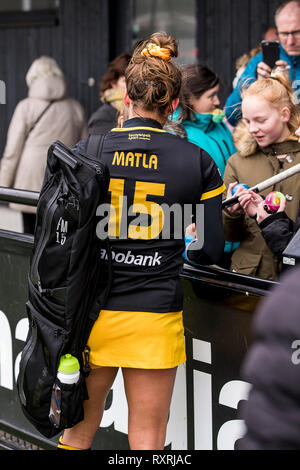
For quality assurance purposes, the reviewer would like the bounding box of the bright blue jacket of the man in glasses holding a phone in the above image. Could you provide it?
[225,46,300,126]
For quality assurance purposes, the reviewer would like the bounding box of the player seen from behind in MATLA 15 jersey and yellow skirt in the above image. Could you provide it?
[59,33,225,450]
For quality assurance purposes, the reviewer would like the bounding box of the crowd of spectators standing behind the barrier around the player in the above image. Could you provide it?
[0,1,300,280]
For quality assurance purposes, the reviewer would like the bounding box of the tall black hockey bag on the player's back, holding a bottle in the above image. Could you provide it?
[17,136,112,438]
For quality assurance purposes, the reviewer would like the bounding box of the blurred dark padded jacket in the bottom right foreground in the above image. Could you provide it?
[236,268,300,450]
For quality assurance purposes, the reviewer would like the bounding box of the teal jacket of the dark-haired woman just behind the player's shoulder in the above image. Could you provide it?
[182,113,236,178]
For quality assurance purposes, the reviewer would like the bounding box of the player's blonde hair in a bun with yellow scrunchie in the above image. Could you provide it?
[125,33,182,115]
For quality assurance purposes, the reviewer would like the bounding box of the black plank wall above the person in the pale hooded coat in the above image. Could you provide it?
[0,0,110,155]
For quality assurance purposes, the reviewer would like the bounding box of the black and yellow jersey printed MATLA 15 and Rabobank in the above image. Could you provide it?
[75,118,225,312]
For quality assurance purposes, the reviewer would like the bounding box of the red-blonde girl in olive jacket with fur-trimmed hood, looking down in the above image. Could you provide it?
[223,74,300,280]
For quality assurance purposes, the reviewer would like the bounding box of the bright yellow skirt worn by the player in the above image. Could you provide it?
[88,310,186,369]
